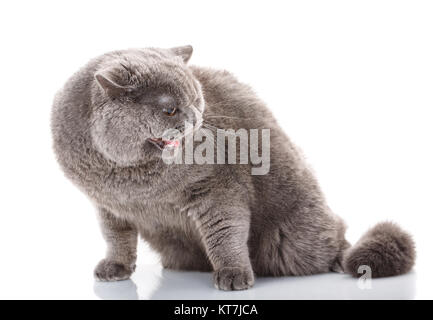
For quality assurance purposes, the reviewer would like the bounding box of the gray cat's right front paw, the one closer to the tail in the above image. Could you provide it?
[214,267,254,290]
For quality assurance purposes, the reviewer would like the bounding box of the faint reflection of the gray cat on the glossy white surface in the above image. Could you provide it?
[94,266,416,300]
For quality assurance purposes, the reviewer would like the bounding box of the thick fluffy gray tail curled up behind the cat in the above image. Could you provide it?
[343,222,415,278]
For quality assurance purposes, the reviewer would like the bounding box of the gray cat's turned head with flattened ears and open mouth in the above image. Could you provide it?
[90,46,204,166]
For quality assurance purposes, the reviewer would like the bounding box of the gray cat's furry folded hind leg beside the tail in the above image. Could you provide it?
[251,212,349,276]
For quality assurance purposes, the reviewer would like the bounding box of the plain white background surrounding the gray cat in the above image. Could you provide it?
[0,0,433,299]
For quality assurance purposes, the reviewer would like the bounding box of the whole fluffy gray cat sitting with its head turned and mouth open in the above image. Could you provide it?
[52,46,415,290]
